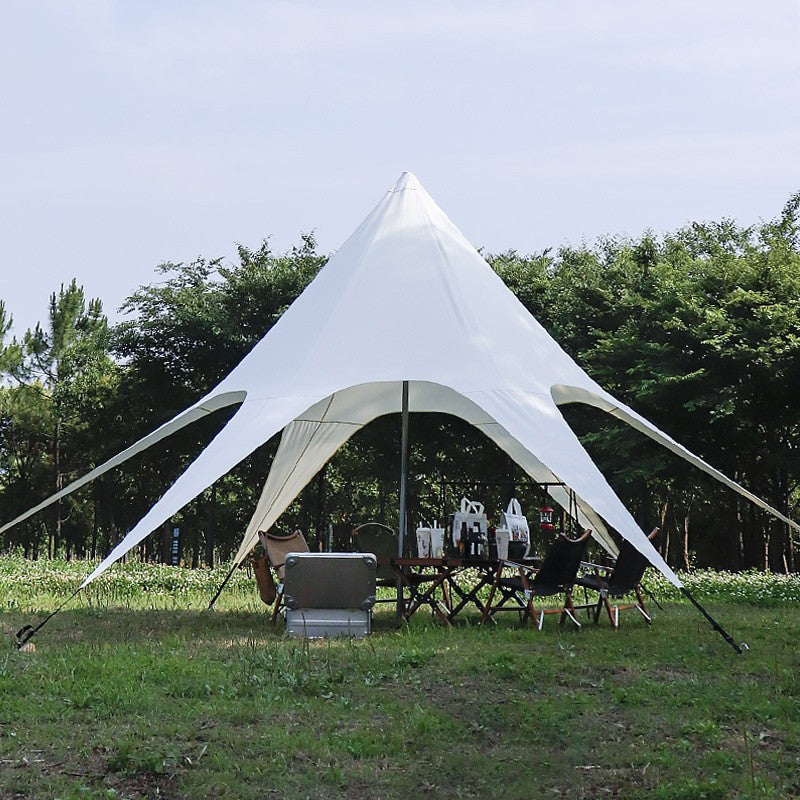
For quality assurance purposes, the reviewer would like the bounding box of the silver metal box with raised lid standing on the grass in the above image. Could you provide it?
[283,553,377,639]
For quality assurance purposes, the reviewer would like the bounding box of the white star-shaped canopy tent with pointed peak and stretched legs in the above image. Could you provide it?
[0,173,800,588]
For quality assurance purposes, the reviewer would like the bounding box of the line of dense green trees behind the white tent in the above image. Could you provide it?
[0,198,800,571]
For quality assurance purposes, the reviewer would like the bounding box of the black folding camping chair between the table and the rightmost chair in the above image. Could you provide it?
[481,530,591,630]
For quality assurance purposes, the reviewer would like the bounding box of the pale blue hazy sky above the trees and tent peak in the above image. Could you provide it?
[0,0,800,335]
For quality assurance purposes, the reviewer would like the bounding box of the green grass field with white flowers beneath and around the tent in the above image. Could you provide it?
[0,559,800,800]
